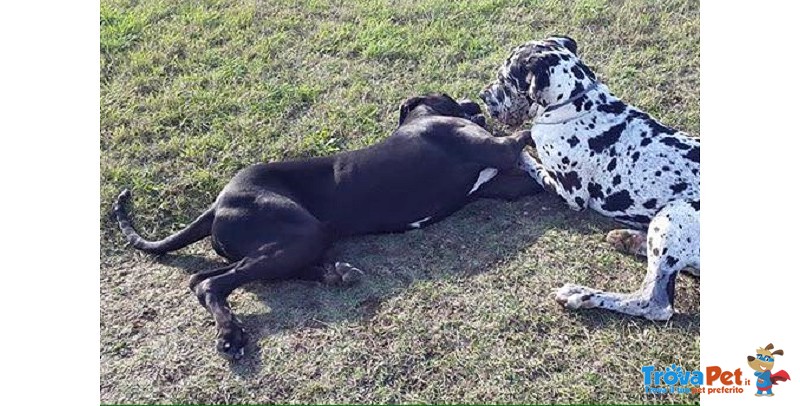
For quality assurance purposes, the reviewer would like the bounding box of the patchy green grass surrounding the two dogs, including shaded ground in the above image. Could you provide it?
[100,0,700,403]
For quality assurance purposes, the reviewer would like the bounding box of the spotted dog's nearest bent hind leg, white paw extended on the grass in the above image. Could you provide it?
[555,201,700,320]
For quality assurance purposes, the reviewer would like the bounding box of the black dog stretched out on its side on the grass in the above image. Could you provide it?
[114,94,541,358]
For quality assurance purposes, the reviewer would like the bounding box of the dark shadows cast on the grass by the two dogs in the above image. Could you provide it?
[161,194,699,376]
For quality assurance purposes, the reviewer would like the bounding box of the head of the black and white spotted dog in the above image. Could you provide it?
[480,36,595,127]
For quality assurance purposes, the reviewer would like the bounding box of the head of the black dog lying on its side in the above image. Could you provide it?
[398,93,486,127]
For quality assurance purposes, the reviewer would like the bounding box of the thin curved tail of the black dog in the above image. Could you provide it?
[114,189,214,255]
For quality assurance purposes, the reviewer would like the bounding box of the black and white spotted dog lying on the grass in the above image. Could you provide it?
[481,37,700,320]
